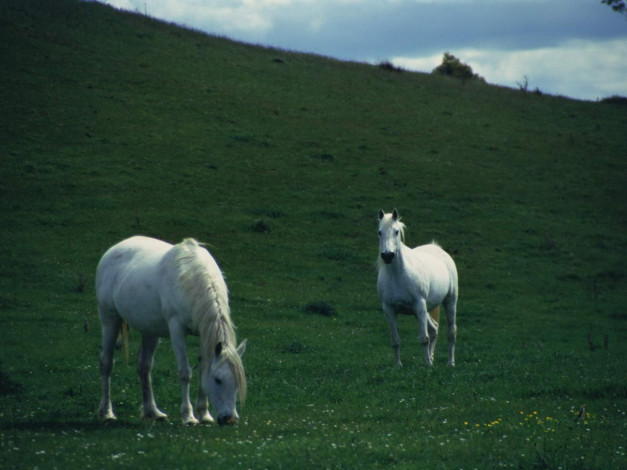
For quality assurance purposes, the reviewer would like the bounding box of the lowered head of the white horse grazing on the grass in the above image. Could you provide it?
[201,340,246,425]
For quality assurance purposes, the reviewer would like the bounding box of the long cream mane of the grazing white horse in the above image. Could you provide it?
[173,238,246,403]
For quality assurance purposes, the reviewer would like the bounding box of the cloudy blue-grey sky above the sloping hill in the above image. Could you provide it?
[98,0,627,100]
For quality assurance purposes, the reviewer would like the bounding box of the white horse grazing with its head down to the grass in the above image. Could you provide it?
[96,236,246,424]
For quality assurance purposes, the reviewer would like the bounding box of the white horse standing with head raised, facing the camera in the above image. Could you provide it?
[377,209,459,367]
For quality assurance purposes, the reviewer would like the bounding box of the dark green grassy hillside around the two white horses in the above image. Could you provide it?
[0,0,627,469]
